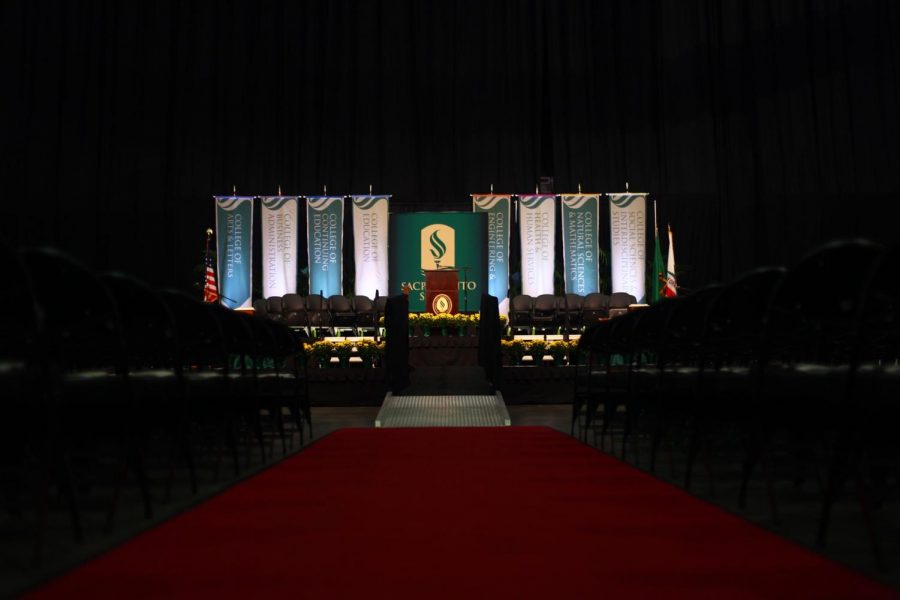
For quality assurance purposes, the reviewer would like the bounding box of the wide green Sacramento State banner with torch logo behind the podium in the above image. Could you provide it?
[388,212,488,312]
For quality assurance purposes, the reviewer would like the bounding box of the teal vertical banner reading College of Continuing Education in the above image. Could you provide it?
[306,196,344,298]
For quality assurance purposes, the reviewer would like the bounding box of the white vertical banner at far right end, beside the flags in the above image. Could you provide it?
[609,194,647,303]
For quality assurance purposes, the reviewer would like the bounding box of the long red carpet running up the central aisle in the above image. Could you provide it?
[26,428,897,598]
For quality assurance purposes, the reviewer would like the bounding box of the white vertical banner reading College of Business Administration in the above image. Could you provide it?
[260,196,298,298]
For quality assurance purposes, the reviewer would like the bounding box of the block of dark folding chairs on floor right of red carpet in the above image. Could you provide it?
[572,240,900,560]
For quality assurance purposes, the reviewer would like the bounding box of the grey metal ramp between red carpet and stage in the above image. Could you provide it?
[375,392,511,427]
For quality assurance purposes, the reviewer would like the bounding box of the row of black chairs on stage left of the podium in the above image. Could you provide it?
[253,294,387,337]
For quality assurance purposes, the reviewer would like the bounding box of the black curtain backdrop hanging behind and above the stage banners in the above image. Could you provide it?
[0,0,900,287]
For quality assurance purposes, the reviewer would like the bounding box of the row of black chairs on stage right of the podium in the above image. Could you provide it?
[509,292,637,334]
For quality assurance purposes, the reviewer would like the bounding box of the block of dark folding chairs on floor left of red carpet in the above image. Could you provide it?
[0,241,312,560]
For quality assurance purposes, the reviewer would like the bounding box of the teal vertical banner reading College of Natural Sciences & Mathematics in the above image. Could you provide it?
[561,194,600,296]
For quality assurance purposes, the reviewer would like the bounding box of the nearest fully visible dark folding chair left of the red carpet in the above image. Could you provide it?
[20,248,153,526]
